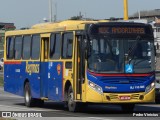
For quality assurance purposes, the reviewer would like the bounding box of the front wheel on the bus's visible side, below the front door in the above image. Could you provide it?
[67,86,78,112]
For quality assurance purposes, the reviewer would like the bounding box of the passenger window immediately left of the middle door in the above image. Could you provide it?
[31,35,40,60]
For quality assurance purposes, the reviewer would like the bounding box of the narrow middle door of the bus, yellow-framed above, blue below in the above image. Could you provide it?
[40,34,49,97]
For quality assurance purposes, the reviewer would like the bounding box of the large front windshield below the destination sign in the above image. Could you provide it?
[88,35,154,73]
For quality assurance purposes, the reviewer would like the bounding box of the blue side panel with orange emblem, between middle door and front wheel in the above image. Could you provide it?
[48,62,63,101]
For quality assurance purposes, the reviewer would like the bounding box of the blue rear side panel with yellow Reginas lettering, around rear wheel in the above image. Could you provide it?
[4,62,40,98]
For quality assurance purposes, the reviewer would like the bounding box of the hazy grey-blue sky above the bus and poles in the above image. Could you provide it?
[0,0,160,28]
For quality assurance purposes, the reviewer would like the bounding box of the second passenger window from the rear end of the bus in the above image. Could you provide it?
[14,36,22,60]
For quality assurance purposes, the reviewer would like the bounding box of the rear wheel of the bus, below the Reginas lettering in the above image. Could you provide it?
[24,82,35,107]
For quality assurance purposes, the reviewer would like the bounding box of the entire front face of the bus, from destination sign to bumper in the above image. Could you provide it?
[86,23,155,111]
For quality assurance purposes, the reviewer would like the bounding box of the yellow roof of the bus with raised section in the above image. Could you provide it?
[6,20,102,36]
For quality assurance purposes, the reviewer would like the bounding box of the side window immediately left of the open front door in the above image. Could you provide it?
[62,33,73,59]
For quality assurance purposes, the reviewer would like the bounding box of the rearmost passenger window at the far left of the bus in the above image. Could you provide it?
[7,37,14,59]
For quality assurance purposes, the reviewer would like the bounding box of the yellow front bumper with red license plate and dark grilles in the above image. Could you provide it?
[86,87,155,104]
